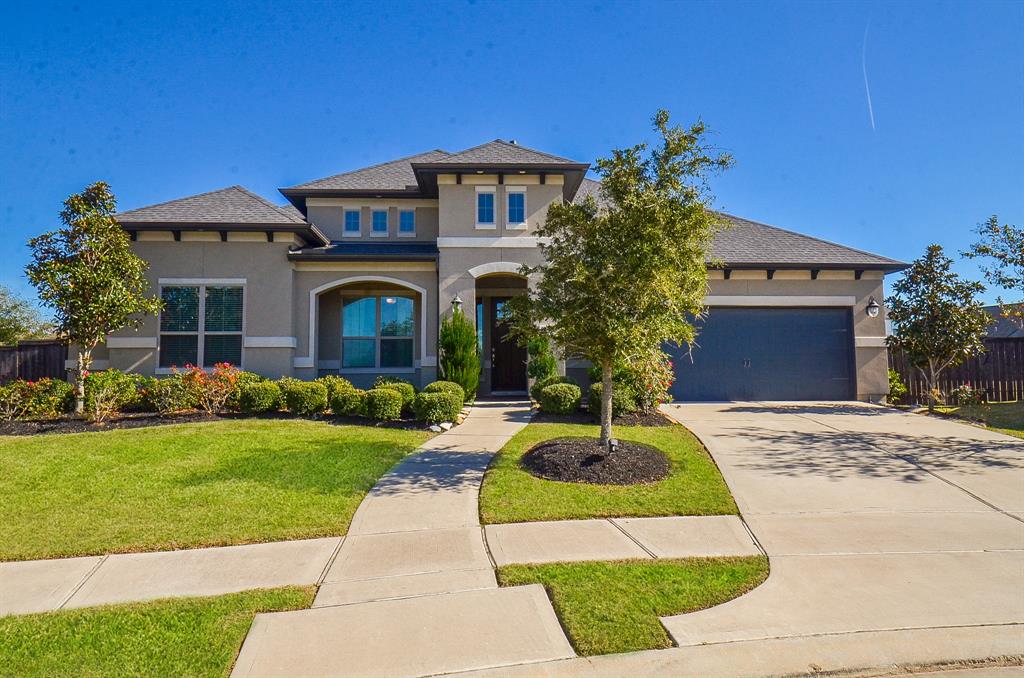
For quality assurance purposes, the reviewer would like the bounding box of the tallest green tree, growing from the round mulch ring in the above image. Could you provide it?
[510,111,732,446]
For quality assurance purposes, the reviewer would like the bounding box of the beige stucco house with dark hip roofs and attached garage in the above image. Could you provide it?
[96,140,903,399]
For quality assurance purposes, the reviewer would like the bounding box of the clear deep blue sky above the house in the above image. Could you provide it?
[0,1,1024,311]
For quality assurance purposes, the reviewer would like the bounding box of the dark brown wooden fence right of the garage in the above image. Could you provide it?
[889,338,1024,405]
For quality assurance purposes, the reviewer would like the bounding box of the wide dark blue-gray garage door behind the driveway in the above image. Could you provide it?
[666,308,854,400]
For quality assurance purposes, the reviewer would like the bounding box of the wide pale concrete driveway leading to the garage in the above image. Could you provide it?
[663,402,1024,652]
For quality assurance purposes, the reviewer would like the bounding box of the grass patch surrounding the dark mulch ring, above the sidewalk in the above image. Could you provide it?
[480,424,736,523]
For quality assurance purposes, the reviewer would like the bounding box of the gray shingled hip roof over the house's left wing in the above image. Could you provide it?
[116,186,305,224]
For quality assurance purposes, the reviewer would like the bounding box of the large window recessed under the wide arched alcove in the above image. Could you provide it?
[341,295,416,369]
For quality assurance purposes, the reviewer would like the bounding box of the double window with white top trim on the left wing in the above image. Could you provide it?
[159,285,243,368]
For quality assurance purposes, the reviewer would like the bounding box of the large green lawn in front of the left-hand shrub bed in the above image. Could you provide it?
[0,419,429,560]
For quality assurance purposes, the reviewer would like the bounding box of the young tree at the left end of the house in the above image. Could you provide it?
[26,181,160,415]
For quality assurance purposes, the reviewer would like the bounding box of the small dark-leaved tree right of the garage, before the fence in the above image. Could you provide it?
[886,245,992,412]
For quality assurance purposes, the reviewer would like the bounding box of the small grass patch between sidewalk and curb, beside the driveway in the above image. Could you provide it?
[498,556,768,654]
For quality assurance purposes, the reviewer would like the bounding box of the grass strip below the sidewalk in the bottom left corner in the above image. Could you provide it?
[0,587,314,677]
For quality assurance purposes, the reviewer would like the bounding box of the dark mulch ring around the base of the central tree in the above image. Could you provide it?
[519,437,672,485]
